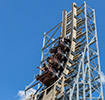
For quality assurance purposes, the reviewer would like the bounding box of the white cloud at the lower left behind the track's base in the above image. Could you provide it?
[18,88,36,100]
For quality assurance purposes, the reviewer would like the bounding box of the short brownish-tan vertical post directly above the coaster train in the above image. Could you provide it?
[61,10,67,37]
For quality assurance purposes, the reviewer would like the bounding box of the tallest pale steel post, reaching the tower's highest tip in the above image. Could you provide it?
[84,2,92,100]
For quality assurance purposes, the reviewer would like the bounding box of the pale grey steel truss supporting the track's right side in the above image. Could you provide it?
[65,2,103,100]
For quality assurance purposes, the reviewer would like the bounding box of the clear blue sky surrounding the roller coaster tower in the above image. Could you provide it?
[0,0,105,100]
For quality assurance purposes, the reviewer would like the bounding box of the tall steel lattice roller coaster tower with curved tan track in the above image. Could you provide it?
[25,2,104,100]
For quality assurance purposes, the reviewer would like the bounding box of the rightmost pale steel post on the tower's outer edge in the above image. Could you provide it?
[93,9,104,100]
